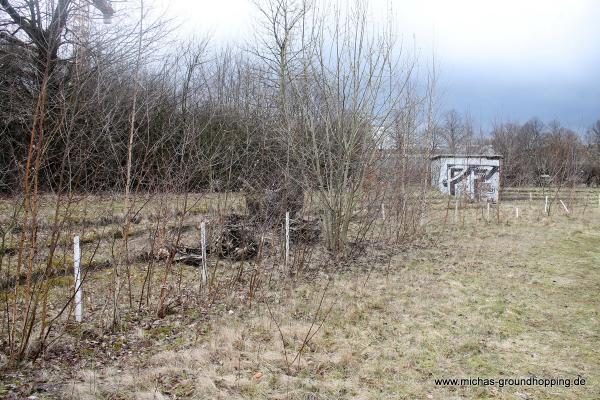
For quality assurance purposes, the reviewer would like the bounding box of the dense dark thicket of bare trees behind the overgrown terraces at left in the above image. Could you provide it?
[0,16,282,193]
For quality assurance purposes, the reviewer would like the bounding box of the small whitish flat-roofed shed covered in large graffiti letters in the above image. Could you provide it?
[431,154,502,202]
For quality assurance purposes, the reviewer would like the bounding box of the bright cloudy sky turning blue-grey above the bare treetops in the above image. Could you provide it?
[148,0,600,133]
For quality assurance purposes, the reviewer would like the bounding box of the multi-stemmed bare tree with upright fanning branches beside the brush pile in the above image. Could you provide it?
[288,1,410,253]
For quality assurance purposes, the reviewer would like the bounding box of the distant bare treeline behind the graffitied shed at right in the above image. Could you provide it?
[431,110,600,186]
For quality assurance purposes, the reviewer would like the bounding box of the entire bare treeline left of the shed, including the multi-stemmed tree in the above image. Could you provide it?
[0,0,436,248]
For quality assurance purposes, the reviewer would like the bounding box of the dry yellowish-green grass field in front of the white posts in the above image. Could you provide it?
[0,193,600,399]
